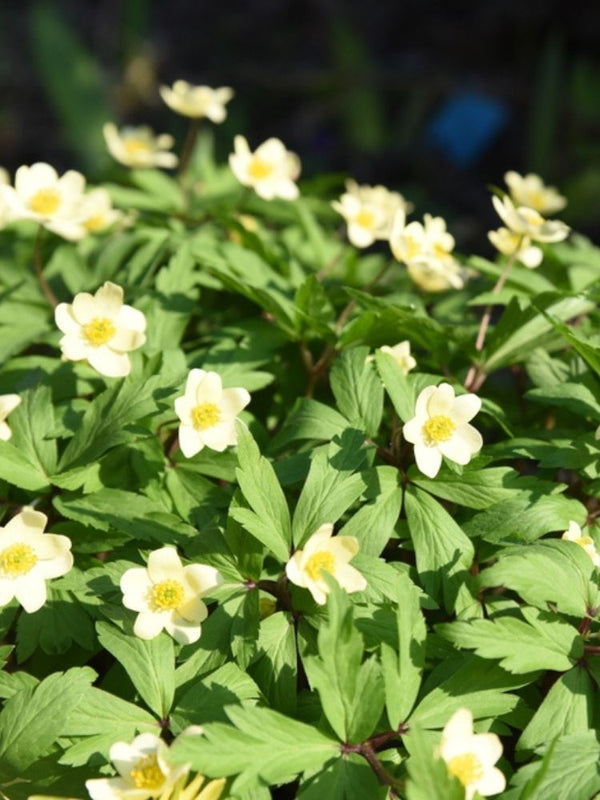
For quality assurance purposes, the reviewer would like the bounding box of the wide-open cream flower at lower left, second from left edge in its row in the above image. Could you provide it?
[121,547,221,644]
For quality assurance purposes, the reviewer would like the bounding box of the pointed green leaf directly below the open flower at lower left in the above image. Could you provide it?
[96,622,175,719]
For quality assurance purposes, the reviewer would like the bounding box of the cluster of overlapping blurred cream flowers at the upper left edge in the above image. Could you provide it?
[0,162,122,241]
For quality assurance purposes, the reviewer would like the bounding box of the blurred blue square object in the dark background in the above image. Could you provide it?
[427,91,508,167]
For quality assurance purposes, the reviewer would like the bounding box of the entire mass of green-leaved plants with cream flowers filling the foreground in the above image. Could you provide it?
[0,81,600,800]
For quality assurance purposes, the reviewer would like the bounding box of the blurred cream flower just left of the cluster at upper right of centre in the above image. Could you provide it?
[331,181,409,247]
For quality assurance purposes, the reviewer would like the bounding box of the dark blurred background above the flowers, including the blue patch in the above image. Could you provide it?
[0,0,600,249]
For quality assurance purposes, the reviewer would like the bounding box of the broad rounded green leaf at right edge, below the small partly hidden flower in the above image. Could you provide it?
[479,539,600,617]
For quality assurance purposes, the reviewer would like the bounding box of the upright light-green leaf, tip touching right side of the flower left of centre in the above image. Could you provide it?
[231,424,292,563]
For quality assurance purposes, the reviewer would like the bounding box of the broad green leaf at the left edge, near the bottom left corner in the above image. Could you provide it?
[0,667,96,778]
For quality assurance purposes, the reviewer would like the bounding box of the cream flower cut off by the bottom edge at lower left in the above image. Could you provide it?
[85,733,189,800]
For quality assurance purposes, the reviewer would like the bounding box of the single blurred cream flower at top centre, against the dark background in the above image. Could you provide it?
[229,136,300,200]
